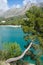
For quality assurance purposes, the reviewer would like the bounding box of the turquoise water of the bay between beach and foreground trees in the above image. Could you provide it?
[0,26,42,63]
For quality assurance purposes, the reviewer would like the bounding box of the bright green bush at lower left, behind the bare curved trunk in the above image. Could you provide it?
[0,42,21,60]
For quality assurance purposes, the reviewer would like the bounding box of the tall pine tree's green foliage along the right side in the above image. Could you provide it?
[22,6,43,65]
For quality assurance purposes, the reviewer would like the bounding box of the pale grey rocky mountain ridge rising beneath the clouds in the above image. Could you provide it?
[1,3,35,18]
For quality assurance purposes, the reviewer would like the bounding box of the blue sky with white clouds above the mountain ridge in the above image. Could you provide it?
[0,0,43,12]
